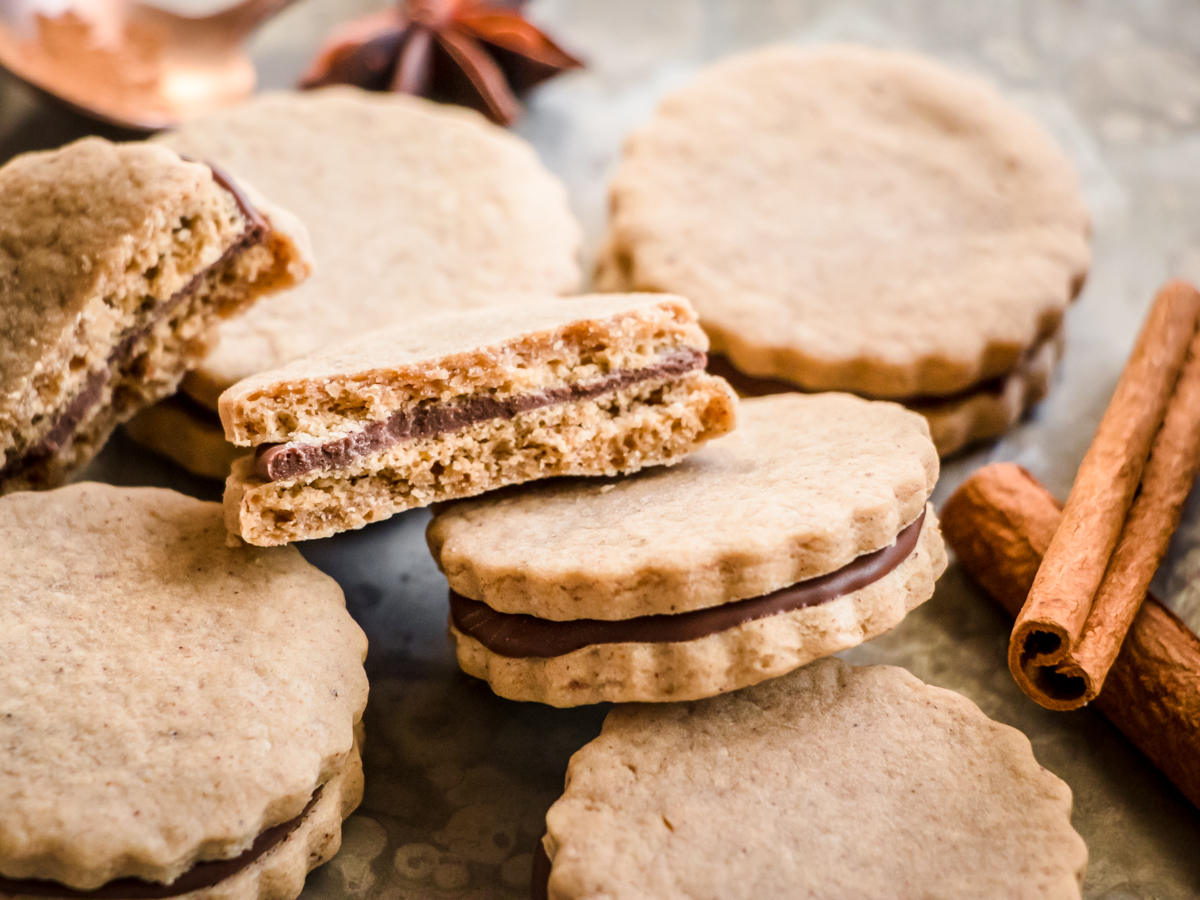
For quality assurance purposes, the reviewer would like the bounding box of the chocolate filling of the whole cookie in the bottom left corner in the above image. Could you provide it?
[0,787,322,900]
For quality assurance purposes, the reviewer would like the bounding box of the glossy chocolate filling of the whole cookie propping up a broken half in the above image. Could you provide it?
[450,510,925,659]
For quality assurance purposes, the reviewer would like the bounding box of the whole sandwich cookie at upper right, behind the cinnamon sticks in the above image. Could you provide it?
[596,46,1090,455]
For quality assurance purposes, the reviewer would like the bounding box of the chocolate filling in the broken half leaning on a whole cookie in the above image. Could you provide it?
[254,347,708,481]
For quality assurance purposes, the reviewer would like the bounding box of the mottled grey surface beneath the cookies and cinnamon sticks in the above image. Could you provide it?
[7,0,1200,900]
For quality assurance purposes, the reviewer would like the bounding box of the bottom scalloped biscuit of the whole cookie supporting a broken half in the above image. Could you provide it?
[450,509,946,707]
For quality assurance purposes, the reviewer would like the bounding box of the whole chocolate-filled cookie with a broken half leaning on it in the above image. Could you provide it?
[427,394,946,707]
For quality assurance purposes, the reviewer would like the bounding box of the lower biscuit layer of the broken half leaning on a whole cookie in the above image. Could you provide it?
[226,371,734,546]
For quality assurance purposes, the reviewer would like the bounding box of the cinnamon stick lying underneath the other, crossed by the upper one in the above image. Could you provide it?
[941,463,1200,808]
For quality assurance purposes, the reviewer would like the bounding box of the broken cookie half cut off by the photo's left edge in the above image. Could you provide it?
[0,138,310,492]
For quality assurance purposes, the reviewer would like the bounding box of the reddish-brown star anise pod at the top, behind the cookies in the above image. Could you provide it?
[300,0,583,125]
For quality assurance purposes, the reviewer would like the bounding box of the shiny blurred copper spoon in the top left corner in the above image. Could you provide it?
[0,0,295,131]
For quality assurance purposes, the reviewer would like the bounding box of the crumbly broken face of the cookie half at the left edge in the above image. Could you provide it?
[0,188,280,492]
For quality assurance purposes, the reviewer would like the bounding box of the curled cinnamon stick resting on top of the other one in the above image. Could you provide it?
[1008,281,1200,709]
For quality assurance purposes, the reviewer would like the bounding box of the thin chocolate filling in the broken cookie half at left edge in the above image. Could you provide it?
[0,164,270,480]
